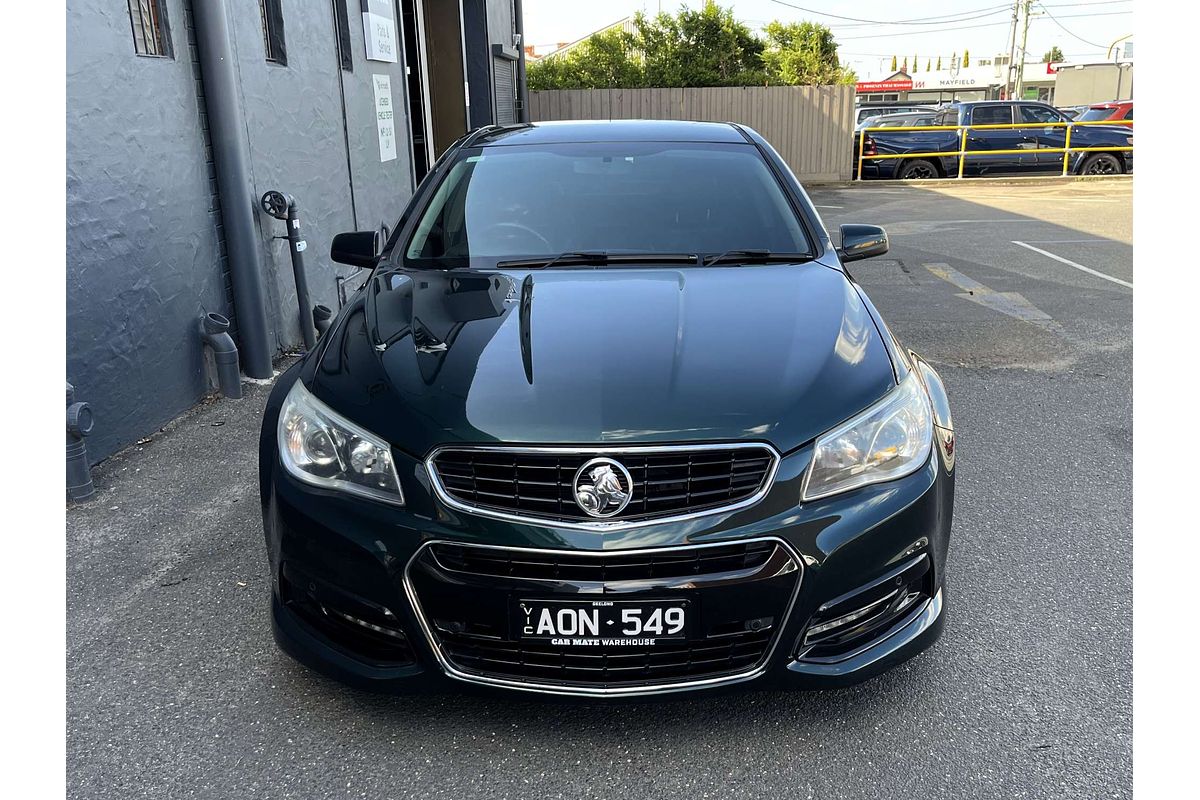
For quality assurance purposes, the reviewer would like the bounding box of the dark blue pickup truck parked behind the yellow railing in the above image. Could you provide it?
[854,101,1133,180]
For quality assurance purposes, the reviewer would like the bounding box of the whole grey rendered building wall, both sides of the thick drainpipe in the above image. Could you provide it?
[66,0,422,461]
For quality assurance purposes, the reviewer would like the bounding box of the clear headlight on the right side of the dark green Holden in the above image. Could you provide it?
[800,372,934,500]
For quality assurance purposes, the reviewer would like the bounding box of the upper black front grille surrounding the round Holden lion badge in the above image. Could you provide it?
[431,444,778,523]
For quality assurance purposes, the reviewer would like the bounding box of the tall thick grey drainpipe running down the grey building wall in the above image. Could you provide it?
[192,0,271,378]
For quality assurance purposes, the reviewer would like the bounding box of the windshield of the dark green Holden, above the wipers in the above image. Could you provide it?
[404,142,812,269]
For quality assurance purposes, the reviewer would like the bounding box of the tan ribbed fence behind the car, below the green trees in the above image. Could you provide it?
[529,86,854,181]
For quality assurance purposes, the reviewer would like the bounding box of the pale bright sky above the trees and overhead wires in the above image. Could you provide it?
[523,0,1134,80]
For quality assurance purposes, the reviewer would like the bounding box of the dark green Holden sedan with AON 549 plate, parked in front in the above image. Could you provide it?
[260,121,954,697]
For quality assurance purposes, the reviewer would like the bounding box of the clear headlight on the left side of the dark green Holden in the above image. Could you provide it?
[278,380,404,505]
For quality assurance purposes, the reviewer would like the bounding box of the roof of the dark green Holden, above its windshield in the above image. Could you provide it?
[464,120,750,148]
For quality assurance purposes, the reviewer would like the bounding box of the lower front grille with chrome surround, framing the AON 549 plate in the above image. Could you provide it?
[406,539,802,693]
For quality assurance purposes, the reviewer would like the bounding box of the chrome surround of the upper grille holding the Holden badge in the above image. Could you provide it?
[425,441,780,531]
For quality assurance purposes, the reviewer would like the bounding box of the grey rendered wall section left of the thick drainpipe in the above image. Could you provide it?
[66,0,231,461]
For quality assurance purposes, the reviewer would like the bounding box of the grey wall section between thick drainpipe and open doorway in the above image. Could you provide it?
[230,0,412,349]
